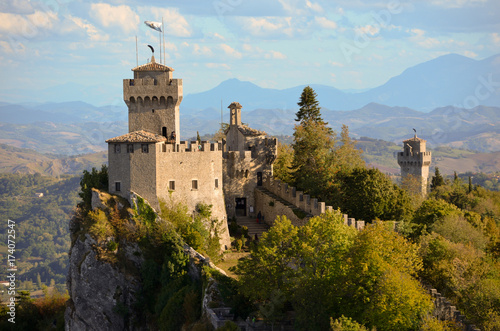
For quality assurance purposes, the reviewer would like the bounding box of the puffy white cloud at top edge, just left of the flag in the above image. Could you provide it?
[90,3,139,33]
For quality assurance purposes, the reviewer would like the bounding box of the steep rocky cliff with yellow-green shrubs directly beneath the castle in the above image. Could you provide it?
[65,190,228,331]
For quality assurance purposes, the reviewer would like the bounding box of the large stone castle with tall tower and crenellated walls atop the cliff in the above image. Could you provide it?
[106,56,277,245]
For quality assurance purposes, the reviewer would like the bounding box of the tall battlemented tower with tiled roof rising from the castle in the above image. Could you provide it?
[123,56,182,144]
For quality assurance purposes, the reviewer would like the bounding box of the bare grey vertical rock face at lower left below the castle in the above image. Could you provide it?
[65,234,146,330]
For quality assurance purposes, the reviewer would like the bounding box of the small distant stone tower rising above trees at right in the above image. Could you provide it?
[398,131,432,195]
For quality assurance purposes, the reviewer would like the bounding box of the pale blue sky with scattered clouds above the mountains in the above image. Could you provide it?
[0,0,500,105]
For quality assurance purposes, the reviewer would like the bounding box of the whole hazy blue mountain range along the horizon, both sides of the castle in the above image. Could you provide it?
[0,54,500,155]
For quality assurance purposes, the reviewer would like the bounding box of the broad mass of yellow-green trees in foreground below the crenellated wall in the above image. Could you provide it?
[235,212,432,330]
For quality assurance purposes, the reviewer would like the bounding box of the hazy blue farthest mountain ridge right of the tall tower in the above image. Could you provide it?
[181,54,500,114]
